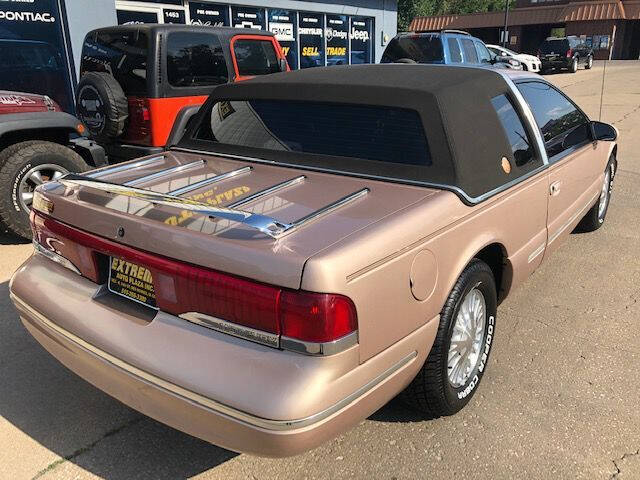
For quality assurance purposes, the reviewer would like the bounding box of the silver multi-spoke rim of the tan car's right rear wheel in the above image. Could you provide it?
[447,288,487,388]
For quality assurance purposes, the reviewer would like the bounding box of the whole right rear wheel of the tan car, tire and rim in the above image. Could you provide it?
[401,259,497,418]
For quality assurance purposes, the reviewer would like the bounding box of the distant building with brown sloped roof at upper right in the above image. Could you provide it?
[409,0,640,60]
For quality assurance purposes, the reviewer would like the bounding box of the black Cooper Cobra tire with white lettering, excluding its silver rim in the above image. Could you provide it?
[401,259,497,418]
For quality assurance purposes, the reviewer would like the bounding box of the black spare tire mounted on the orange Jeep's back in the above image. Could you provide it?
[76,72,129,141]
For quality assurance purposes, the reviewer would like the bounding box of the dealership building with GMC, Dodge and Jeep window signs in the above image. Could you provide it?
[0,0,398,111]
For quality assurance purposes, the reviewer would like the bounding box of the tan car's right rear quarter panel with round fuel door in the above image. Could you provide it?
[302,171,548,362]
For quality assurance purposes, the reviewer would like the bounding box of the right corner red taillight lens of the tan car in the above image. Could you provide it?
[280,291,358,343]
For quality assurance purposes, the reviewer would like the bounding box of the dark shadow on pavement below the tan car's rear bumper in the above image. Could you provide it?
[0,280,238,479]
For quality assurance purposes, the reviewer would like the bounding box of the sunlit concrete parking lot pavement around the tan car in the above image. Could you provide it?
[0,62,640,479]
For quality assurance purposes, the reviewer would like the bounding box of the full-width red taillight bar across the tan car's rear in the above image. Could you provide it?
[31,214,358,343]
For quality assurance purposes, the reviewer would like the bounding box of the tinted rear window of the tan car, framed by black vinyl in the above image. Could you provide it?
[196,100,431,167]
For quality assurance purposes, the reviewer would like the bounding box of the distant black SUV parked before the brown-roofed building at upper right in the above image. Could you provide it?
[538,35,593,73]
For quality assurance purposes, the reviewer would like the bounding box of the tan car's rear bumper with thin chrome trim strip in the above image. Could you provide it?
[10,255,438,457]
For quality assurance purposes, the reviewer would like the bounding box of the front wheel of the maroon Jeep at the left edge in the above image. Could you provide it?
[0,140,89,238]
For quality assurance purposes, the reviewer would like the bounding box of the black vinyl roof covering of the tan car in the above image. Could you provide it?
[185,64,536,198]
